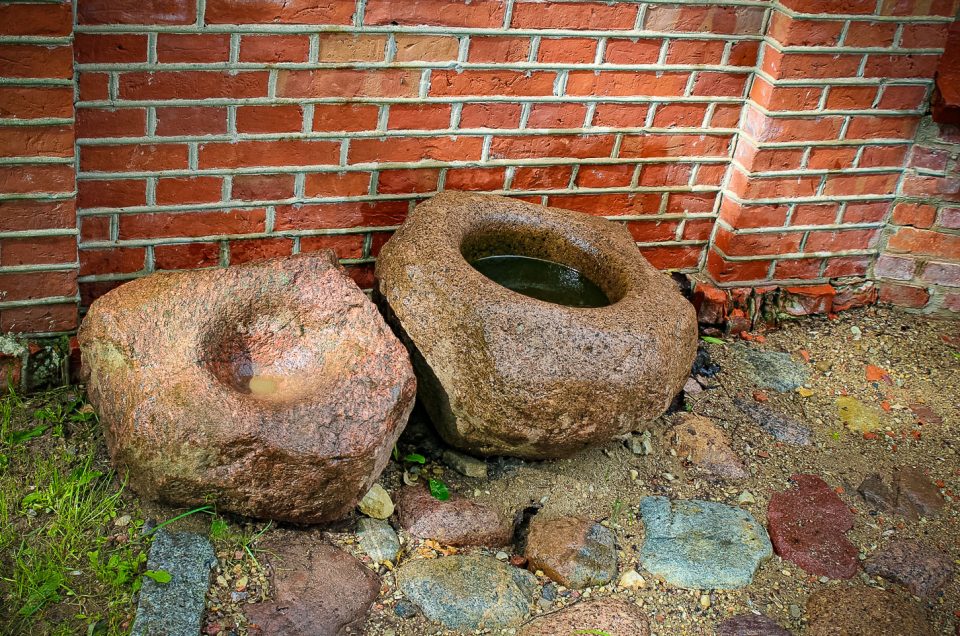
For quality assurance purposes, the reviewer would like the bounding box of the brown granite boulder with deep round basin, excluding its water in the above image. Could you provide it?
[375,192,697,458]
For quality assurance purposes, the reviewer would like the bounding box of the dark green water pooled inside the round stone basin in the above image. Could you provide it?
[470,256,610,307]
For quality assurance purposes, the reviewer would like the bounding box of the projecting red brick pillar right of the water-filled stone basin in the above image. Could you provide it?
[706,0,957,298]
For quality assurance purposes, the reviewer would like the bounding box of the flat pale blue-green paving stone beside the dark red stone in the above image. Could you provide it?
[640,497,773,589]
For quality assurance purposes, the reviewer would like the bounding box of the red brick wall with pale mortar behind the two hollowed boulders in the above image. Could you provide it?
[0,0,960,338]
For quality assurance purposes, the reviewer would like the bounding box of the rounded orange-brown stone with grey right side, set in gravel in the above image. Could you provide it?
[524,517,617,589]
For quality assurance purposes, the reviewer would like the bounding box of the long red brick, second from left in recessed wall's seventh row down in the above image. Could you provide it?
[120,209,266,240]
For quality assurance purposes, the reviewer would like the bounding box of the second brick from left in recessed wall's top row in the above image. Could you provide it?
[204,0,355,24]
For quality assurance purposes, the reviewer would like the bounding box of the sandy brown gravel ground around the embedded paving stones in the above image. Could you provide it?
[197,308,960,636]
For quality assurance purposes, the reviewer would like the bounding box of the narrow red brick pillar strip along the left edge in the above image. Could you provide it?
[0,0,78,334]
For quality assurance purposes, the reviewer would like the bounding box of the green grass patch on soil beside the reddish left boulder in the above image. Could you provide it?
[0,388,149,634]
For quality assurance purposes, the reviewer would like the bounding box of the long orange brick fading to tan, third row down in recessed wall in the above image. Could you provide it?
[277,68,420,98]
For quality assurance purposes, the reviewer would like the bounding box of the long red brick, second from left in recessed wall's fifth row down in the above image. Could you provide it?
[198,139,340,169]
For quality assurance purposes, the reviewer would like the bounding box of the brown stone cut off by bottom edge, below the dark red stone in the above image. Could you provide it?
[804,587,935,636]
